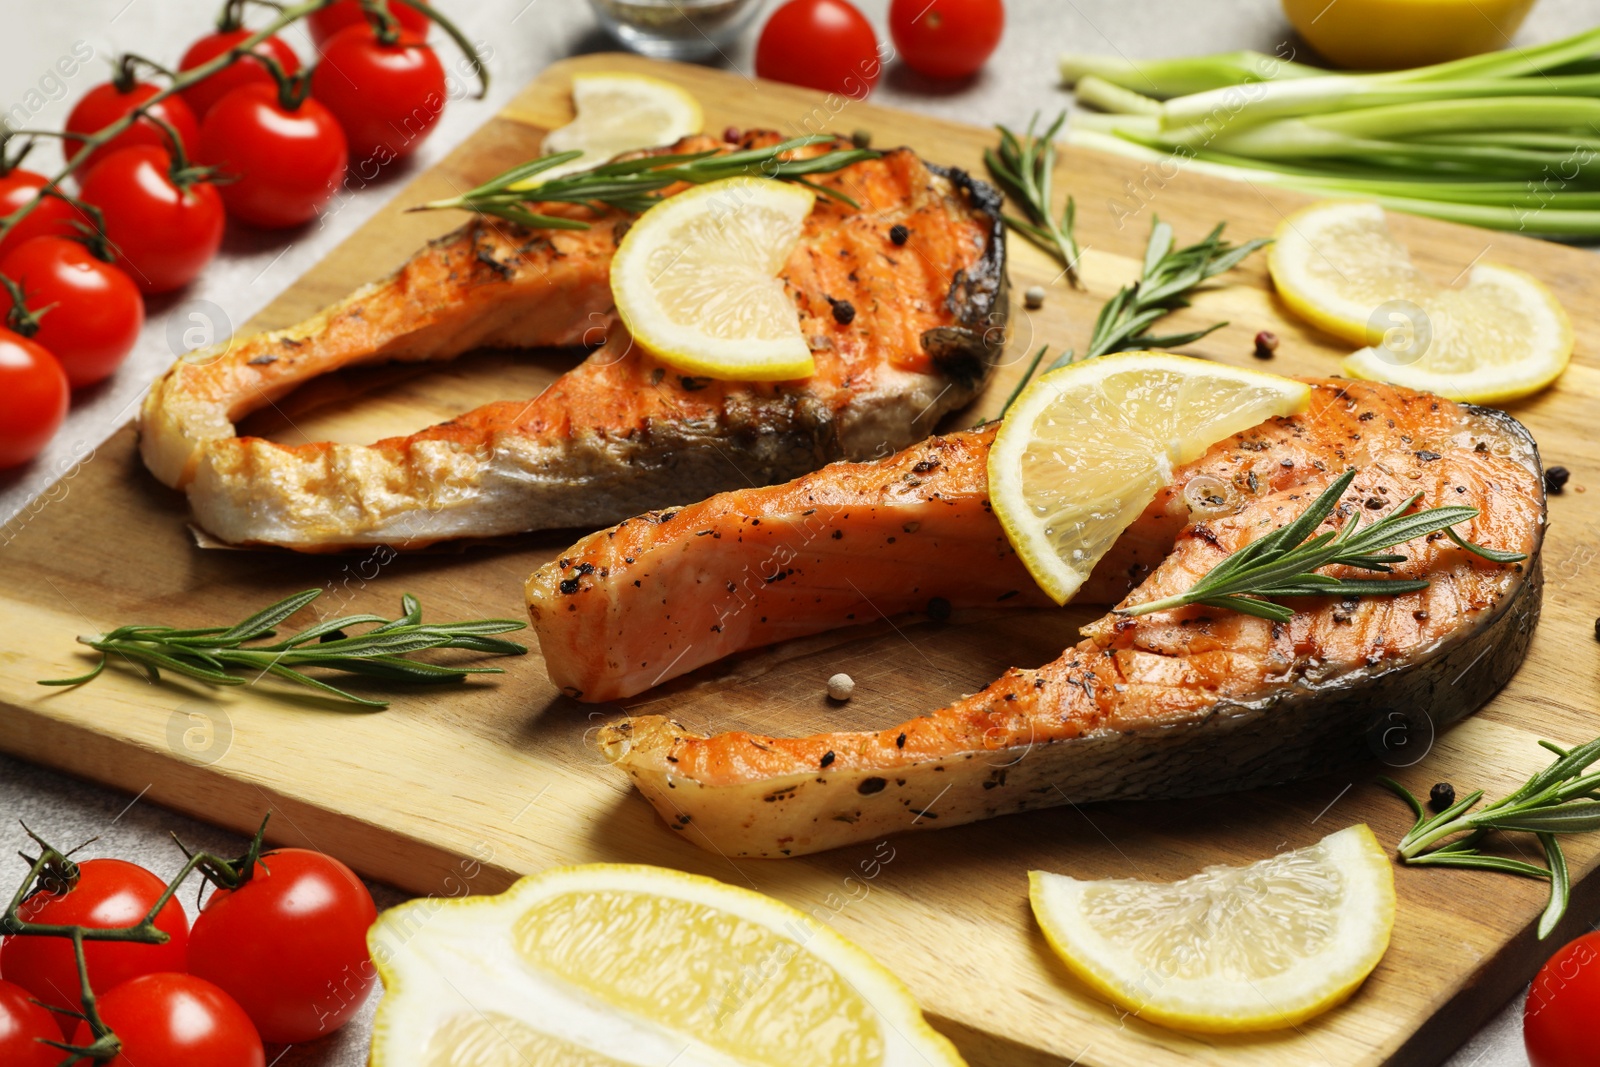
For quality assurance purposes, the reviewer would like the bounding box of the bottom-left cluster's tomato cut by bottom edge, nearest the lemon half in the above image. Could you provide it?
[72,979,267,1067]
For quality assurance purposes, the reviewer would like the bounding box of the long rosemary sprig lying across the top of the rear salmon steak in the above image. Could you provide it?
[411,134,882,230]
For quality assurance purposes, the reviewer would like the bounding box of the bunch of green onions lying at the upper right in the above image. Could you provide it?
[1061,29,1600,237]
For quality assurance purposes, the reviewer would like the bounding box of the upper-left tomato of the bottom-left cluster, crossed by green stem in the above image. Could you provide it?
[0,857,189,1025]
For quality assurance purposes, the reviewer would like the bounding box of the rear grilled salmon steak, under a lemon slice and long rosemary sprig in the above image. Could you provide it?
[139,131,1008,552]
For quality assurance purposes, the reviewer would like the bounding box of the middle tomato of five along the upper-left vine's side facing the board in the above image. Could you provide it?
[82,144,226,294]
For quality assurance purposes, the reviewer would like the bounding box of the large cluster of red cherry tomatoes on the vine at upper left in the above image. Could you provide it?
[0,0,475,470]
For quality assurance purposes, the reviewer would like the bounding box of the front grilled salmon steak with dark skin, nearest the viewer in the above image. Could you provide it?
[563,379,1544,856]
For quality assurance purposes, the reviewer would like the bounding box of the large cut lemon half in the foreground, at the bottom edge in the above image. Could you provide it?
[368,864,962,1067]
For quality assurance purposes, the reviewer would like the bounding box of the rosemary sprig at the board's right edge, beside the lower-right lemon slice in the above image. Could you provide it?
[1378,737,1600,941]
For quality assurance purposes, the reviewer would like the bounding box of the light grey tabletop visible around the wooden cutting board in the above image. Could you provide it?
[0,0,1594,1067]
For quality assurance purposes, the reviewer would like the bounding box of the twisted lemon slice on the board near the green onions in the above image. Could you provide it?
[1267,202,1573,403]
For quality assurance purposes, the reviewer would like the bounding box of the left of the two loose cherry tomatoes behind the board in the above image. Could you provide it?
[755,0,883,99]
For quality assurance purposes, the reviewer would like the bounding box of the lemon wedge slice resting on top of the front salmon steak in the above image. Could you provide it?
[989,352,1310,603]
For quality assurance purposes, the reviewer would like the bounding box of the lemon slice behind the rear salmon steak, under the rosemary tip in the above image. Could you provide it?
[534,72,706,181]
